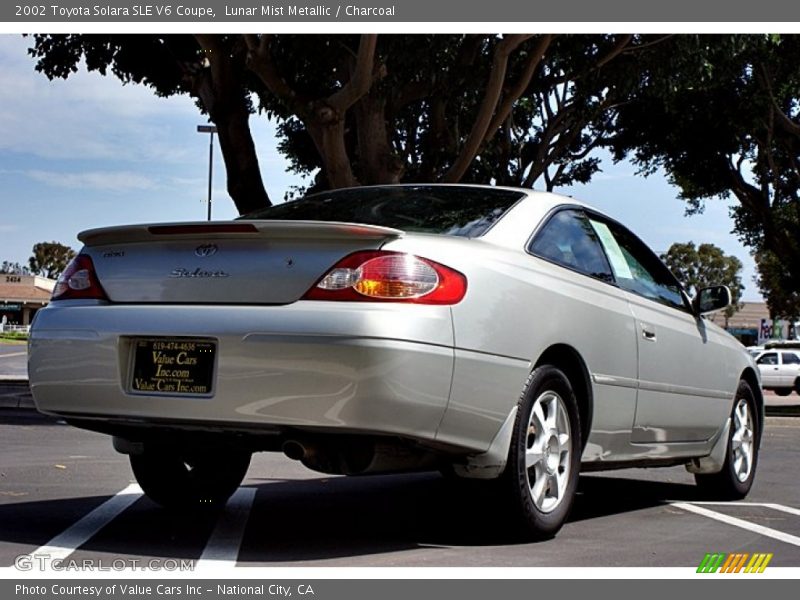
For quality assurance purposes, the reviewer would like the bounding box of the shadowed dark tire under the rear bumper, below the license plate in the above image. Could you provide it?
[130,446,252,510]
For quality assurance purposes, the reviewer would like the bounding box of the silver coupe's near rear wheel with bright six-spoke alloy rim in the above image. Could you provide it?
[503,365,581,539]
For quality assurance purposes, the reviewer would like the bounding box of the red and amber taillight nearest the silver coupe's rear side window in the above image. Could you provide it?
[303,251,467,304]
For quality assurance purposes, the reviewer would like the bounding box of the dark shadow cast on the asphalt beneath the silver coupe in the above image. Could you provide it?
[0,473,698,566]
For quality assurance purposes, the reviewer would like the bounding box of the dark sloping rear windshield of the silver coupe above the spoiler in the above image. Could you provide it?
[240,186,524,237]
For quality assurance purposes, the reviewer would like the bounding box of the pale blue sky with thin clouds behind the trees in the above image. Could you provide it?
[0,33,761,301]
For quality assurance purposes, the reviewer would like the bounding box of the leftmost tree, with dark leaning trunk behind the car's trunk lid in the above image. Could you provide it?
[28,34,270,214]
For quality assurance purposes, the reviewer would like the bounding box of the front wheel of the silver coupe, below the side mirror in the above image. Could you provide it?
[694,381,761,500]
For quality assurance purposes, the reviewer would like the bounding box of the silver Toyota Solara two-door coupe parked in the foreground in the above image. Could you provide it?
[29,185,764,538]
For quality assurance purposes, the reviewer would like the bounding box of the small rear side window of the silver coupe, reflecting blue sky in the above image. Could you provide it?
[529,209,613,281]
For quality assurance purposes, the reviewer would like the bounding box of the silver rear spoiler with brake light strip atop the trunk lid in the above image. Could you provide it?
[78,221,404,246]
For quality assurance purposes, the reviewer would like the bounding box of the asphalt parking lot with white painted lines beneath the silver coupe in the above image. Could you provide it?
[0,400,800,572]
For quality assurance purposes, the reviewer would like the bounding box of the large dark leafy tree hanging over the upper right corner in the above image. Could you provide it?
[611,35,800,301]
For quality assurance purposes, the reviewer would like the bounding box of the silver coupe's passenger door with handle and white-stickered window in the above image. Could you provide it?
[592,218,737,443]
